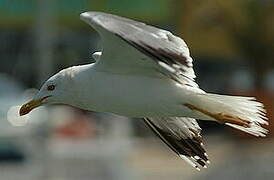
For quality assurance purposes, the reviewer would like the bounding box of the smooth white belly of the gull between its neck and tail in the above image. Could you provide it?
[72,73,197,117]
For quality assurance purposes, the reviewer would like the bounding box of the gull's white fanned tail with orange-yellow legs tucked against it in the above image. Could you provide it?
[186,94,268,137]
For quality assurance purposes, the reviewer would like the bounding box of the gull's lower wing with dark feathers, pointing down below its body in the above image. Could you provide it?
[144,117,209,170]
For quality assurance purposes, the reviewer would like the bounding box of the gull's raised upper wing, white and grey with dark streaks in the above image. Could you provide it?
[81,12,198,87]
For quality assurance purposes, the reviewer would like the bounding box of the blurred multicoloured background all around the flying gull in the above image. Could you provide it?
[0,0,274,180]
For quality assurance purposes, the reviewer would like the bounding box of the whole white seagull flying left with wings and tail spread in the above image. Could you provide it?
[19,12,268,170]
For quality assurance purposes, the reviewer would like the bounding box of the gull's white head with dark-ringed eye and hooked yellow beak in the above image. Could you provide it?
[19,68,72,116]
